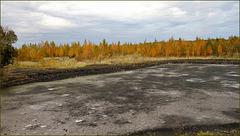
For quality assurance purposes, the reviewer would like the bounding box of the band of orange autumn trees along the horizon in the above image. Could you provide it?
[15,36,240,62]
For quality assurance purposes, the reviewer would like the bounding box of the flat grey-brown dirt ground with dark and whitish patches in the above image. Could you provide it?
[1,64,239,135]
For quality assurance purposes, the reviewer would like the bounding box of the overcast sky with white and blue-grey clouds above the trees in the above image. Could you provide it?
[1,1,239,47]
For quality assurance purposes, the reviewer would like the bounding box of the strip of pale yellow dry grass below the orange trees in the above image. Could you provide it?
[6,55,239,69]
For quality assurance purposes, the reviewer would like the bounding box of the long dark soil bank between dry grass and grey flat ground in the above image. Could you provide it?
[1,59,240,89]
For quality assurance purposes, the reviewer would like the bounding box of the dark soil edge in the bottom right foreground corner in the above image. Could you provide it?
[125,123,239,136]
